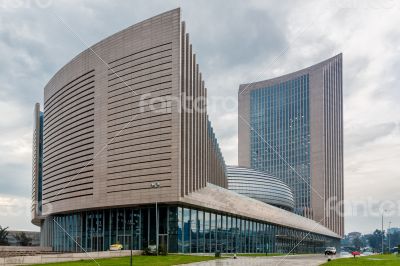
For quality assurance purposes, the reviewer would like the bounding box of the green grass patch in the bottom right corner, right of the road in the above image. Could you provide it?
[322,254,400,266]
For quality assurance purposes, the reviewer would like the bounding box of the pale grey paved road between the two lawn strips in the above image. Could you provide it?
[180,255,336,266]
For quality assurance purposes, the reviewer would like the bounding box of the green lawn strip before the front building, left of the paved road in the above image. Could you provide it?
[27,255,220,266]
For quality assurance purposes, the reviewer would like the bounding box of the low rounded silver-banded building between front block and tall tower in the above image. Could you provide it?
[226,166,294,211]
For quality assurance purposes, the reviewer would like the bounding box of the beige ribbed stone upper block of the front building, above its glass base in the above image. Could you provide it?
[38,11,226,215]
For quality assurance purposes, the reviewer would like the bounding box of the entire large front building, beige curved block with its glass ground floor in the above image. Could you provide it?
[32,9,338,253]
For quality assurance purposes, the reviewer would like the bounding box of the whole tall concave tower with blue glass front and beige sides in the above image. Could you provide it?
[238,54,343,235]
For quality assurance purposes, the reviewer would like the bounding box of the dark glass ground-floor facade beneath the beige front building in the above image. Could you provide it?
[41,206,339,253]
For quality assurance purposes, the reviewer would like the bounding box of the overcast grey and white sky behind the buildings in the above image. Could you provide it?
[0,0,400,233]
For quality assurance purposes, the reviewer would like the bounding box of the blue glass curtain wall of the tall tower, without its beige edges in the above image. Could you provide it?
[249,75,311,214]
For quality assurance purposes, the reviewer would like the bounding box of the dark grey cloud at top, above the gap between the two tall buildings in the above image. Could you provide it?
[184,4,287,68]
